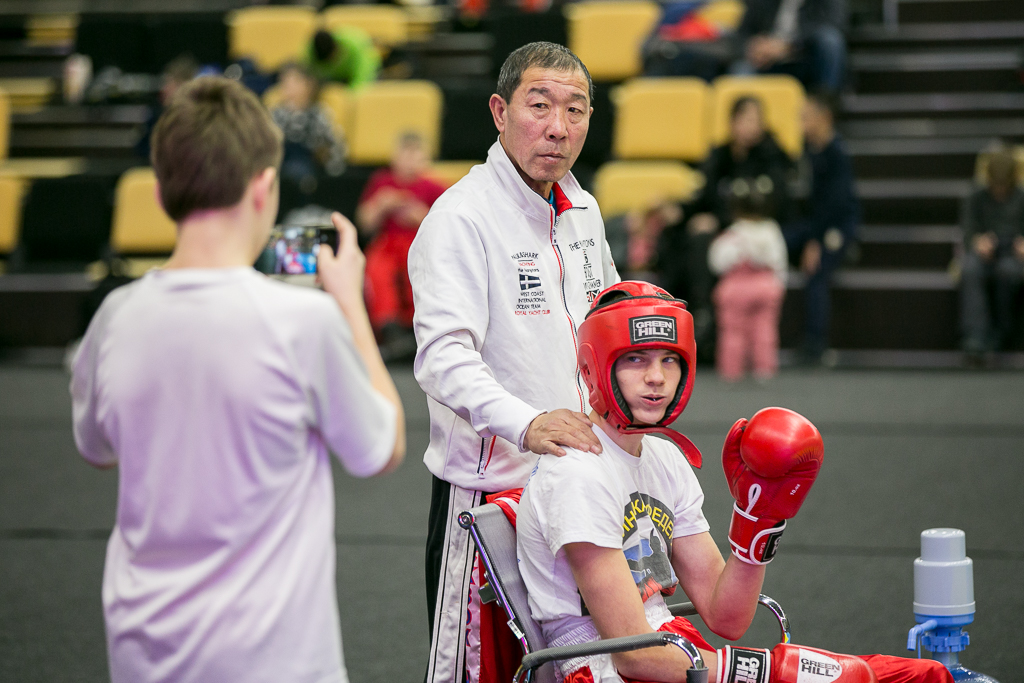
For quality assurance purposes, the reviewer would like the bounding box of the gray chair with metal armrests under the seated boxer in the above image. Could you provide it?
[459,503,792,683]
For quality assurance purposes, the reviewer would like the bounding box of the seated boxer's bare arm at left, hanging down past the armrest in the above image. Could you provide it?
[563,539,718,682]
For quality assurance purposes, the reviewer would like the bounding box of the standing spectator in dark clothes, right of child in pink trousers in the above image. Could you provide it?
[783,93,860,362]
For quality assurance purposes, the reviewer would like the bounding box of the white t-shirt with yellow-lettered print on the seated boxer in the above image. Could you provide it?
[516,425,709,681]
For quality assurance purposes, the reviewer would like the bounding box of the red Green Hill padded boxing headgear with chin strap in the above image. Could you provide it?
[579,282,701,467]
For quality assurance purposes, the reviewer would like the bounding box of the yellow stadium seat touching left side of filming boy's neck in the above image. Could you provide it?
[111,168,177,254]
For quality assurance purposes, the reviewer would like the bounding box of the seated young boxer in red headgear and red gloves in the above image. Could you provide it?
[517,282,952,683]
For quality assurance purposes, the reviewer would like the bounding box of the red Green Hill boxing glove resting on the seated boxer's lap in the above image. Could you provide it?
[717,643,879,683]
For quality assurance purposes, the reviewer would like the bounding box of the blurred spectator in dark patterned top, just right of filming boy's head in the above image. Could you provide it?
[270,63,345,194]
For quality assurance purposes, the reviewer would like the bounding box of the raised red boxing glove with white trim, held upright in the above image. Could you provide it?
[722,408,824,564]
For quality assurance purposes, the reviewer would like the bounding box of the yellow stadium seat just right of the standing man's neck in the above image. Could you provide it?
[594,161,703,218]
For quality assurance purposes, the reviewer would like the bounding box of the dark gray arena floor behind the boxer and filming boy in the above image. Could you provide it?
[0,366,1024,683]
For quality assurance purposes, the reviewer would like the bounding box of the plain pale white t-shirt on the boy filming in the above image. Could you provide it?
[72,268,395,683]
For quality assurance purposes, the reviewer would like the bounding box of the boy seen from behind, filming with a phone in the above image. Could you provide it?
[71,78,404,683]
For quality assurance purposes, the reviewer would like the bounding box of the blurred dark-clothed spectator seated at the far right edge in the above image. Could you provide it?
[961,151,1024,354]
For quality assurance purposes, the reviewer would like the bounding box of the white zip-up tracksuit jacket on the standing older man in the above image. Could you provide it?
[409,142,618,492]
